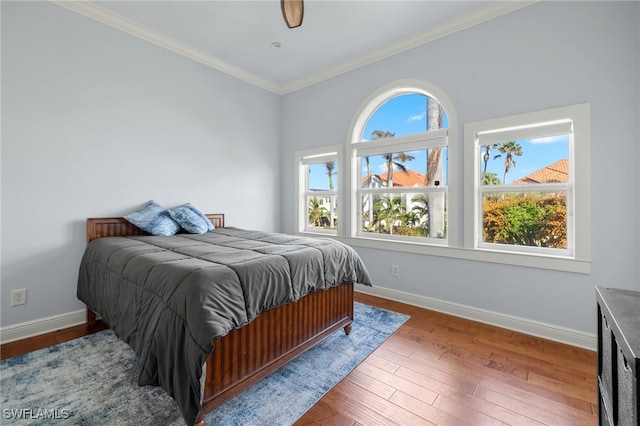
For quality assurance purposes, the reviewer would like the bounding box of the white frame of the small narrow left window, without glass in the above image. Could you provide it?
[295,145,344,236]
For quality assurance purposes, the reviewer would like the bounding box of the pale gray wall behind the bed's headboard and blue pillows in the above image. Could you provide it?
[0,1,280,327]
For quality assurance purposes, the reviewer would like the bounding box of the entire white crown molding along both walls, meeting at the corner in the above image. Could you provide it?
[49,0,541,95]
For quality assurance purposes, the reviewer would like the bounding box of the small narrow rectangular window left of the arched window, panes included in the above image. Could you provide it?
[296,145,342,235]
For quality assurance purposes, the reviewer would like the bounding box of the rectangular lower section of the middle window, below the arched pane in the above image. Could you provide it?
[352,129,448,244]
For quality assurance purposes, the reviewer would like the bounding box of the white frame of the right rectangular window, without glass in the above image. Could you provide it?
[464,103,591,264]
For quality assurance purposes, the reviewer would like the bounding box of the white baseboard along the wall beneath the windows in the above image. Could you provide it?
[356,284,598,351]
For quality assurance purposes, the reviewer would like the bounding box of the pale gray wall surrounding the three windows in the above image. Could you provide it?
[282,2,640,333]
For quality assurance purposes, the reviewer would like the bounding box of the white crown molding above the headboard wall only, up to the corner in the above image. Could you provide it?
[49,0,282,94]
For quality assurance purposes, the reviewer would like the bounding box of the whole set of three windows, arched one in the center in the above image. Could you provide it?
[296,80,591,273]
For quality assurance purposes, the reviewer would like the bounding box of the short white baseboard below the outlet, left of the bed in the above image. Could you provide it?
[0,309,87,344]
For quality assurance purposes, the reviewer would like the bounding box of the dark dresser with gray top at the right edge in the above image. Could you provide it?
[596,287,640,426]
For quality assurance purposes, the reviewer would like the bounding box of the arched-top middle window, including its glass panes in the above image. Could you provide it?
[351,84,449,244]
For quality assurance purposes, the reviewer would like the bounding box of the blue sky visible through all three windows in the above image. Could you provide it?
[309,94,569,190]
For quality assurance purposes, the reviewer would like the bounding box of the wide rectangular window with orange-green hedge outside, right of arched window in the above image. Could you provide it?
[465,105,590,258]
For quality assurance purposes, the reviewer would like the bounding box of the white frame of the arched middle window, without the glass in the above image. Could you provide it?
[343,80,457,246]
